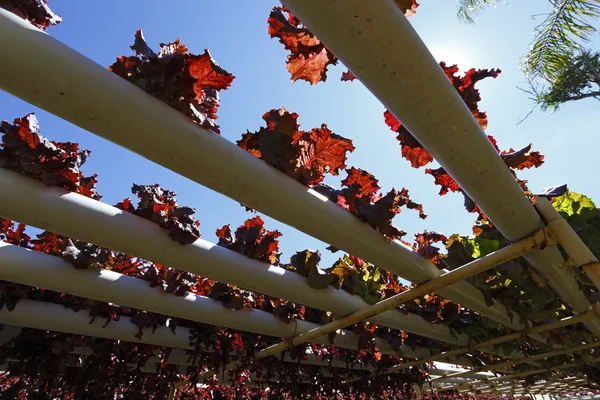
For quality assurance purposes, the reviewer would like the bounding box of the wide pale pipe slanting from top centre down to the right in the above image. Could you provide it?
[282,0,600,335]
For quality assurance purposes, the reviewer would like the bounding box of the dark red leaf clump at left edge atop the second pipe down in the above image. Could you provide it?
[0,113,101,200]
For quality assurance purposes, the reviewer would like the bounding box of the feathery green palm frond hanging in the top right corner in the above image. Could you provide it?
[522,0,600,82]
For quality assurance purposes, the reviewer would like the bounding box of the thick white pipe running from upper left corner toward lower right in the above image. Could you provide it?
[0,7,524,336]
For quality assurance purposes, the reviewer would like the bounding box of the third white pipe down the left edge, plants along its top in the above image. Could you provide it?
[0,242,430,358]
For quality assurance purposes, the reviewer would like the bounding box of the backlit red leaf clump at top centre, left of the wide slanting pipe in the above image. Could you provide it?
[267,7,337,85]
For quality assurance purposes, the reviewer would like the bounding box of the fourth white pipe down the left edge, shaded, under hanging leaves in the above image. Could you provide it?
[0,299,192,349]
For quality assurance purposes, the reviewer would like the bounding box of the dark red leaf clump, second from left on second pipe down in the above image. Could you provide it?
[116,184,200,245]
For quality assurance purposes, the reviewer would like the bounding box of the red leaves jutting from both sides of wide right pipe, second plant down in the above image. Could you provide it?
[383,62,501,168]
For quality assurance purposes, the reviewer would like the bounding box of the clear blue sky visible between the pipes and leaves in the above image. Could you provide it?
[0,0,600,267]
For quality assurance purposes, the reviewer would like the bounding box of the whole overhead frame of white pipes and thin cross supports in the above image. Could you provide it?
[0,0,600,397]
